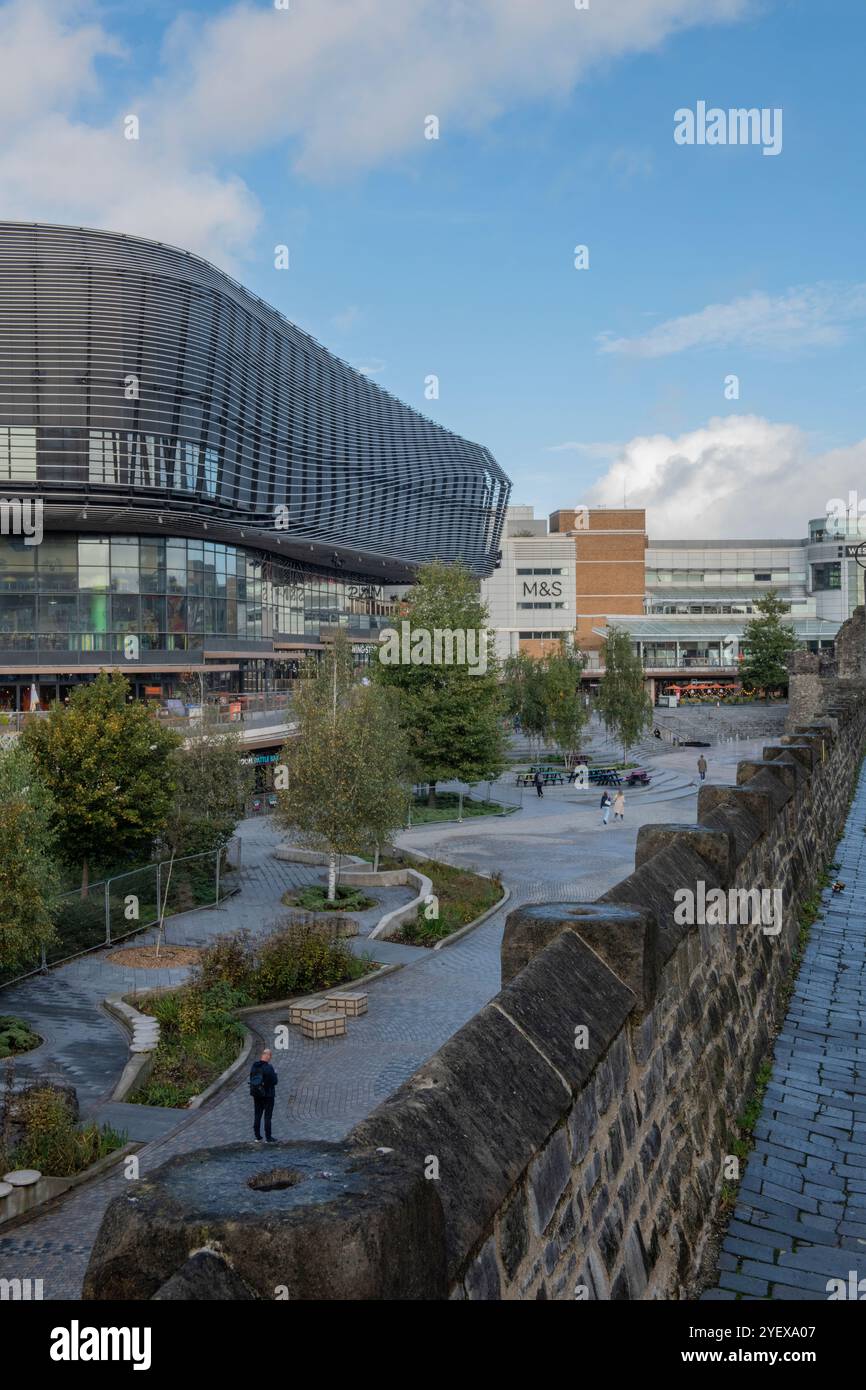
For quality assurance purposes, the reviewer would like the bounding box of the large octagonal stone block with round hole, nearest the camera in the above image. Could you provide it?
[83,1143,448,1304]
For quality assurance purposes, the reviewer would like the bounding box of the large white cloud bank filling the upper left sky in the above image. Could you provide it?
[0,0,755,267]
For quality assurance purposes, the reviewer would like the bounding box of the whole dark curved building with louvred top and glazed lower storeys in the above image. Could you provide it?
[0,222,509,709]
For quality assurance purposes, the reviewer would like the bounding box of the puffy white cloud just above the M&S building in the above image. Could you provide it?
[588,416,866,539]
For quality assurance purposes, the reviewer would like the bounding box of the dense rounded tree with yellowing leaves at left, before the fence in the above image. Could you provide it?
[22,671,181,898]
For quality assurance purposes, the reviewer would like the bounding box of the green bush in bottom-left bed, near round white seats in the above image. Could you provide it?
[1,1087,126,1177]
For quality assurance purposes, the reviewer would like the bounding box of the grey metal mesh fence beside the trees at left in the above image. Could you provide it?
[0,837,242,988]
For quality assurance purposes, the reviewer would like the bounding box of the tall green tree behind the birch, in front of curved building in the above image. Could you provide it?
[375,562,505,805]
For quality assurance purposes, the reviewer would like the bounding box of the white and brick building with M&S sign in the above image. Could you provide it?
[482,506,863,695]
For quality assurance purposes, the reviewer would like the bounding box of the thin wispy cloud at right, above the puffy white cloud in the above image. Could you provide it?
[599,284,866,357]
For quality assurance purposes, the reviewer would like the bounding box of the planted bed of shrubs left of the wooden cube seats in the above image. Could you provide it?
[128,920,374,1108]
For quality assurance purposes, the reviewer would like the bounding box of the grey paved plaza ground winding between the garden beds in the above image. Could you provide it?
[0,745,751,1300]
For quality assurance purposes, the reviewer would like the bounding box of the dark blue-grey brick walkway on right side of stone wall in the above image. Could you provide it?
[703,769,866,1301]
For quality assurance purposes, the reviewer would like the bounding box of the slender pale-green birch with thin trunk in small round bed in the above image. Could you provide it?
[277,632,409,902]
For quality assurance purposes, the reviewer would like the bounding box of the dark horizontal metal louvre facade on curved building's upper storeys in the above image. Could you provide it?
[0,222,509,581]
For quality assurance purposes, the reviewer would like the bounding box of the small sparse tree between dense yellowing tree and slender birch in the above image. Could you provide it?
[163,706,256,855]
